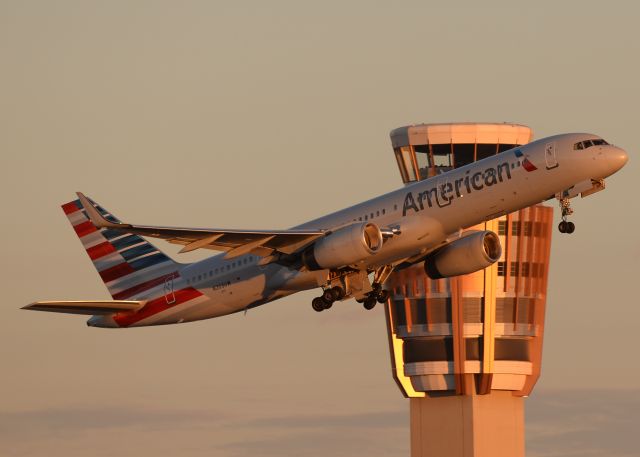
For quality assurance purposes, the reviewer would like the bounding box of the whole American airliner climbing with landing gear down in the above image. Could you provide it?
[23,133,628,328]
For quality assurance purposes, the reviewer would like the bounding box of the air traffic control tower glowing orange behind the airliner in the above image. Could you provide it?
[385,123,553,457]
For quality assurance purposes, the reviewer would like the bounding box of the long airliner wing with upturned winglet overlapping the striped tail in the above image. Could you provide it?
[78,192,325,259]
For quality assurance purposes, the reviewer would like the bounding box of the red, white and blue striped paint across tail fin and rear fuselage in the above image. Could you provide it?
[62,200,206,327]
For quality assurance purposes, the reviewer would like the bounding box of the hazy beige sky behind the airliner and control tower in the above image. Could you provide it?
[0,0,640,456]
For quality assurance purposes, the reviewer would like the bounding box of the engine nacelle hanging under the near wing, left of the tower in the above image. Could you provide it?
[302,222,382,270]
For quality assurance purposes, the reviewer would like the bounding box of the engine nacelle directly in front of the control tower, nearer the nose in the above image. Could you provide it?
[424,231,502,279]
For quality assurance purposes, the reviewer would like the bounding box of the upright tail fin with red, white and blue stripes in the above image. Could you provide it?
[62,195,180,300]
